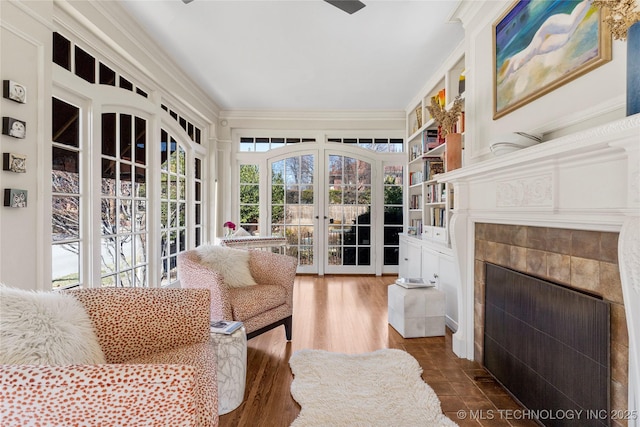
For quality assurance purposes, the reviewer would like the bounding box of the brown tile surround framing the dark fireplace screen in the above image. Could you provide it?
[474,223,629,425]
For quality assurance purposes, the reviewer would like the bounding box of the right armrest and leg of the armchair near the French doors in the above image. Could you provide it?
[249,249,298,306]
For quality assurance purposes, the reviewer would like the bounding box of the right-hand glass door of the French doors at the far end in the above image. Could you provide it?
[325,154,375,274]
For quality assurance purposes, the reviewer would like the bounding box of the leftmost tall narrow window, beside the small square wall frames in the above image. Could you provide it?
[51,98,83,289]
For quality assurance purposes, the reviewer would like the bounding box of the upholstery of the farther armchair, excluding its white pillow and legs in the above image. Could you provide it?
[178,250,298,340]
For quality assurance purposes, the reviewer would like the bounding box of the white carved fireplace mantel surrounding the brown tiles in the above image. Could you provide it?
[442,114,640,426]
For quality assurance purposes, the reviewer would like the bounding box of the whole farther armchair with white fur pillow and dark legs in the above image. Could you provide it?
[178,246,298,340]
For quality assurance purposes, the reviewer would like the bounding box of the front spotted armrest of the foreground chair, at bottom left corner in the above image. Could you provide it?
[0,365,196,427]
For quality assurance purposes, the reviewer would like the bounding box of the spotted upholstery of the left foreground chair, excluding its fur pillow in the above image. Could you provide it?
[0,288,218,427]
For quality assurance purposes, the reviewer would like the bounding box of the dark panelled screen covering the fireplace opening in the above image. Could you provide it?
[482,263,611,427]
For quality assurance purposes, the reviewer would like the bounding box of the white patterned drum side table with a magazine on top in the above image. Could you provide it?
[211,326,247,415]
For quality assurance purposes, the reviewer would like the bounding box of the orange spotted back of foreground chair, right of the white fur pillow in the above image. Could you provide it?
[68,288,210,363]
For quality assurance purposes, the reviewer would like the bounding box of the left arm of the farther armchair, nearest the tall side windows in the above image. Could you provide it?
[178,250,233,320]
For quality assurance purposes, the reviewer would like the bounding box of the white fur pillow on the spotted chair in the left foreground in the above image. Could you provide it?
[0,285,106,365]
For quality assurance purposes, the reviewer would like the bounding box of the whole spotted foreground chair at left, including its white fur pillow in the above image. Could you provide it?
[0,287,218,427]
